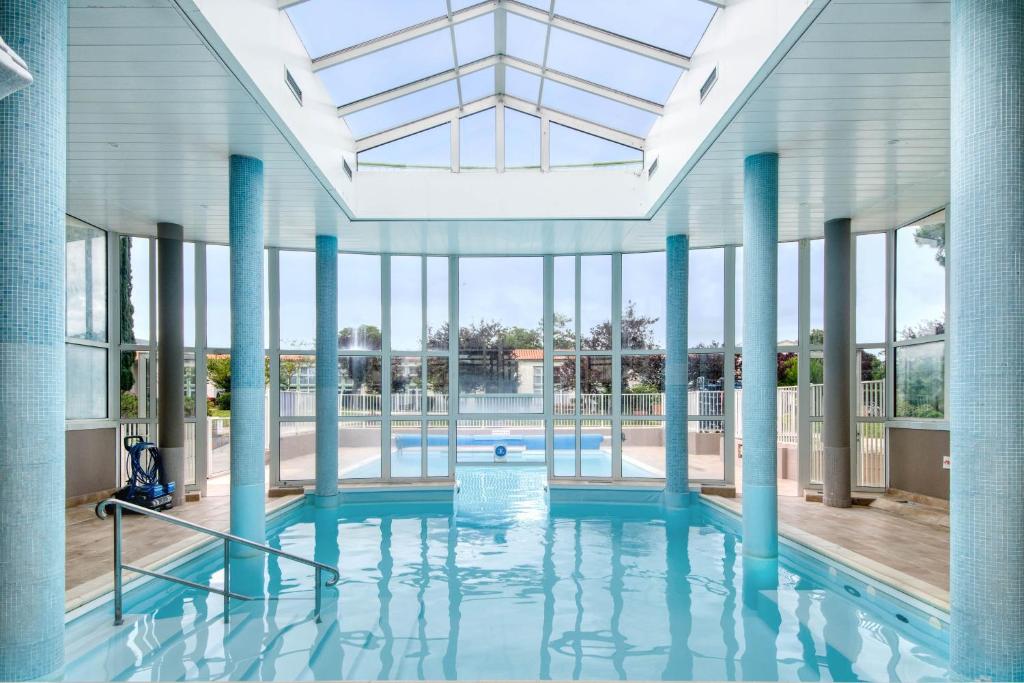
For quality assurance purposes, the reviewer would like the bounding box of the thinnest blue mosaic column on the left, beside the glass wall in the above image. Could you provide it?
[316,234,338,507]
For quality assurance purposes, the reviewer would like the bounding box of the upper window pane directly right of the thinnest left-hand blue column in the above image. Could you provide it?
[338,254,381,350]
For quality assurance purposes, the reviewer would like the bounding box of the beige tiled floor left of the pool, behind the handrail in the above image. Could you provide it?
[65,478,297,609]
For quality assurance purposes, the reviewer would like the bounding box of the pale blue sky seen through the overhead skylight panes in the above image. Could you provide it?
[287,0,715,168]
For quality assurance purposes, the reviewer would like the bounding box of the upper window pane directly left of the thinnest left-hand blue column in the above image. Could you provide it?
[279,251,316,349]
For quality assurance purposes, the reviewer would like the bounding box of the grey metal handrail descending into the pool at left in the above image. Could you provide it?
[96,498,341,626]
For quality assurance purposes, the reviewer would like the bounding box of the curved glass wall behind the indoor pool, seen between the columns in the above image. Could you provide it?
[97,209,945,492]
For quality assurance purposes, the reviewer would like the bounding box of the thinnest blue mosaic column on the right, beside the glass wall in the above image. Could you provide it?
[665,234,690,507]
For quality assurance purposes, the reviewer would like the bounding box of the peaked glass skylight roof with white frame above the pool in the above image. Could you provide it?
[286,0,716,170]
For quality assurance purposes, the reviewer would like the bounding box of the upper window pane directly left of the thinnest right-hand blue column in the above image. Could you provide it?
[622,252,666,349]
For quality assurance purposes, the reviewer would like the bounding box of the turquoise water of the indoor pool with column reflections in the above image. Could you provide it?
[66,466,947,681]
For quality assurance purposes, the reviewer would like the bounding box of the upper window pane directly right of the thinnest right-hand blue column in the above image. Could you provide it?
[688,249,729,348]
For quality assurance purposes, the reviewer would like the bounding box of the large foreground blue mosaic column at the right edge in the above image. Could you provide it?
[947,0,1024,681]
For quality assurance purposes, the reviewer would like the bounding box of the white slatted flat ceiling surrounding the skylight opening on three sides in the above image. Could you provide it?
[68,0,949,254]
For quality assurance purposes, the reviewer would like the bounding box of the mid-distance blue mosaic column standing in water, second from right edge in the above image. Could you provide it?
[742,154,778,558]
